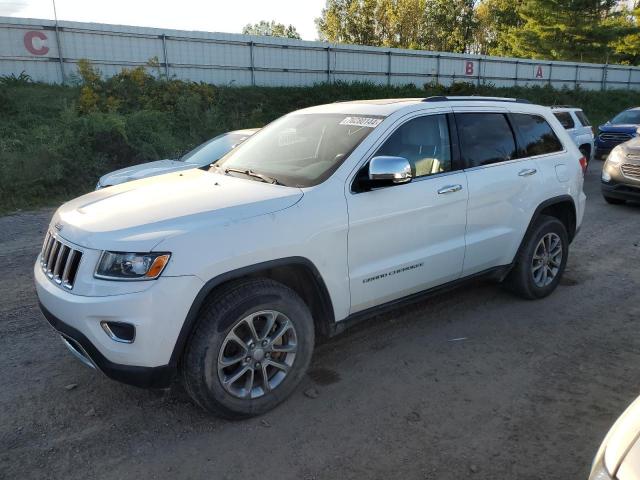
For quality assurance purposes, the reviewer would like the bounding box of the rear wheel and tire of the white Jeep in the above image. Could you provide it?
[505,215,569,300]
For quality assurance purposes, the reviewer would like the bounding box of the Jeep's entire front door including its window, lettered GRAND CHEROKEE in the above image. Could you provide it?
[346,110,467,312]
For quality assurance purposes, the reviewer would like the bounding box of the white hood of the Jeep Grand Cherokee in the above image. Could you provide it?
[51,169,303,251]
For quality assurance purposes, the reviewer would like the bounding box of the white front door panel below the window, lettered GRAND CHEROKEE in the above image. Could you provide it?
[347,172,467,313]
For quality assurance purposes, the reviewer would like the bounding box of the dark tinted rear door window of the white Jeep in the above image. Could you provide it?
[456,113,517,167]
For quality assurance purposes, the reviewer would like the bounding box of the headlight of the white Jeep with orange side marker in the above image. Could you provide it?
[95,252,171,280]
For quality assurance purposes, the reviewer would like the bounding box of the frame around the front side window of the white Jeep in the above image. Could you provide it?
[346,109,464,195]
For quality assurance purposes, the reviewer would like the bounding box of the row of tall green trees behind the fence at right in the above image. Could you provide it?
[316,0,640,63]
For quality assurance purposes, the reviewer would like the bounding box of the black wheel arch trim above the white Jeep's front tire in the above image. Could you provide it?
[170,257,335,367]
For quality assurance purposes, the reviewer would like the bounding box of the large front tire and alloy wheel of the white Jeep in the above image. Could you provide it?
[181,279,315,419]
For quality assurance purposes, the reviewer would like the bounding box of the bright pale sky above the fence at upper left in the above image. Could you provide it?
[0,0,325,40]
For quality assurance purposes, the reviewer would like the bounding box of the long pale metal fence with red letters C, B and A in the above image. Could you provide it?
[0,17,640,90]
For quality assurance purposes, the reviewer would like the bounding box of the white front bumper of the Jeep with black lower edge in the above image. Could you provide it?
[34,259,203,387]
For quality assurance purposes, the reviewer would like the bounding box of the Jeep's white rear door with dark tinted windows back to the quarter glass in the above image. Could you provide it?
[454,108,548,276]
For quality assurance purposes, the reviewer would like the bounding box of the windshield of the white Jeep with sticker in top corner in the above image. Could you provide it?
[216,114,383,187]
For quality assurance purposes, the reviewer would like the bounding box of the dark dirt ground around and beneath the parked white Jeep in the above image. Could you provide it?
[0,165,640,480]
